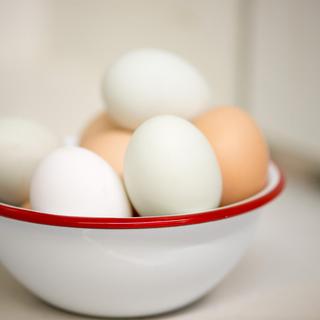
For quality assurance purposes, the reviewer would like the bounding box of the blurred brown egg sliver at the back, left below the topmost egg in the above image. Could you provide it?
[80,112,117,144]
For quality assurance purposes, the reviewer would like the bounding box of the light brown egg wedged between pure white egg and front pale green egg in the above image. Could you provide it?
[81,129,132,176]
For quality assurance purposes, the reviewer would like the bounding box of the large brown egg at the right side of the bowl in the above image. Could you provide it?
[193,107,269,205]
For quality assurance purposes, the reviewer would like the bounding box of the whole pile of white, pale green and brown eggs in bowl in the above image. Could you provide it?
[0,49,269,217]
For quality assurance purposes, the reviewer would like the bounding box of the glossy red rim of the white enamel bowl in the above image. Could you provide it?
[0,164,285,229]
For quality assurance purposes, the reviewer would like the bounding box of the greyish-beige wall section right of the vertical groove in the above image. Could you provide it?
[249,0,320,168]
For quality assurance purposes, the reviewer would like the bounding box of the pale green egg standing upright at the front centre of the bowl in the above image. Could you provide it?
[124,115,222,216]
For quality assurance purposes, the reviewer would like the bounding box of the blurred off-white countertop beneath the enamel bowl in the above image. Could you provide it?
[0,174,320,320]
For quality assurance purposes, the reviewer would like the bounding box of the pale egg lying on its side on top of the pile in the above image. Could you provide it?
[102,48,212,129]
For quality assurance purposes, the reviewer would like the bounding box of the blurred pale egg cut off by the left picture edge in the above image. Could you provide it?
[0,117,59,205]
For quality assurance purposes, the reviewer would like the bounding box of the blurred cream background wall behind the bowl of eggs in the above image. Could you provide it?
[0,0,320,167]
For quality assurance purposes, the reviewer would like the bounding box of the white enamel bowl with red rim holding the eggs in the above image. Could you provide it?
[0,164,284,317]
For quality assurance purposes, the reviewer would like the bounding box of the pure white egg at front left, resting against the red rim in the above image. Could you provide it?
[30,146,131,217]
